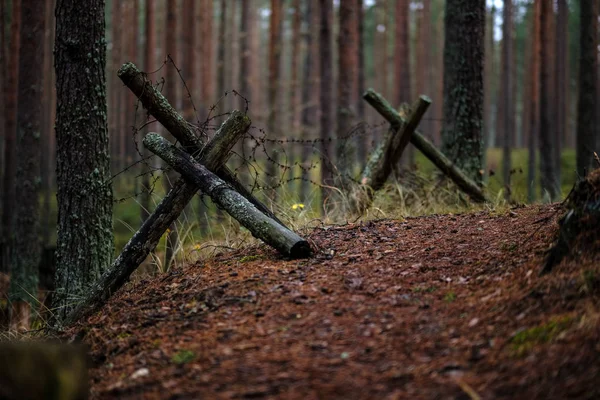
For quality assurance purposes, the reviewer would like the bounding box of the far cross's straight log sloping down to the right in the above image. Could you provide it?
[363,89,488,203]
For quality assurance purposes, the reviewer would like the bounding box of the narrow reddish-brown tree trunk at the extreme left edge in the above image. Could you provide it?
[2,0,21,272]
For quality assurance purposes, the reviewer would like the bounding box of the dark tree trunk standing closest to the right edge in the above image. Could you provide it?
[577,0,598,176]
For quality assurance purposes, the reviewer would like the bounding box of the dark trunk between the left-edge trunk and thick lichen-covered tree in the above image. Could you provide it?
[9,0,46,329]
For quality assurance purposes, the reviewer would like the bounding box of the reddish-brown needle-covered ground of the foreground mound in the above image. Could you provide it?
[70,204,600,399]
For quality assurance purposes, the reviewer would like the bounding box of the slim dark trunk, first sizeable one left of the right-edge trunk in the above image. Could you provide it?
[539,1,560,201]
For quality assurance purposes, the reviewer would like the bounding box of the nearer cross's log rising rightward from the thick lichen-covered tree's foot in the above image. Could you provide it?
[64,111,251,326]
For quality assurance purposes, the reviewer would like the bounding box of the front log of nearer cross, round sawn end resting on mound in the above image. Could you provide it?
[144,133,311,258]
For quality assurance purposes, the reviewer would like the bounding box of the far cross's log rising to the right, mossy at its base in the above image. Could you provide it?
[355,96,431,211]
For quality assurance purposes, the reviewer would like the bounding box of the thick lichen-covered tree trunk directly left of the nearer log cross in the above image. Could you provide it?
[53,0,113,320]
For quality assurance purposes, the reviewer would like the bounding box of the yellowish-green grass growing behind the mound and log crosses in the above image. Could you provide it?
[36,149,576,276]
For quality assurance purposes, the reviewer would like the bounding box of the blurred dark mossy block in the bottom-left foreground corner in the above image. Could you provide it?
[0,342,89,400]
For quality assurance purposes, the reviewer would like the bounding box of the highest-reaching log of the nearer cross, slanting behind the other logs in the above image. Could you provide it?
[117,62,283,225]
